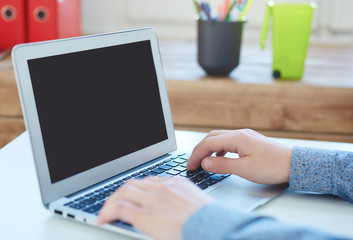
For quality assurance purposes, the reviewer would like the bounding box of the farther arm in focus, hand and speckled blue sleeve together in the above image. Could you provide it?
[188,129,353,202]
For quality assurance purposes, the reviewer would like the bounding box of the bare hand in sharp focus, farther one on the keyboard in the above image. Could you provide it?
[187,129,292,184]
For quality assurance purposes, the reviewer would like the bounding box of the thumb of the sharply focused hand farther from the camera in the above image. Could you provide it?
[201,157,246,174]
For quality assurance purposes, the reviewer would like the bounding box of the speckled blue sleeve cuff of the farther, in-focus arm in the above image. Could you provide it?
[289,147,353,202]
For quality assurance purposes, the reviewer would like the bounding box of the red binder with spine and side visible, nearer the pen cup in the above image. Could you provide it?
[27,0,81,42]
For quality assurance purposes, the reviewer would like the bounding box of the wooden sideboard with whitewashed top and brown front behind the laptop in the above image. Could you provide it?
[0,41,353,148]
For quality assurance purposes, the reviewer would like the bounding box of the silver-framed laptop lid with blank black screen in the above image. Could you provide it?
[12,28,176,205]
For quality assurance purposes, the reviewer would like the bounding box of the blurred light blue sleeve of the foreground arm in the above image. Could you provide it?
[182,203,339,240]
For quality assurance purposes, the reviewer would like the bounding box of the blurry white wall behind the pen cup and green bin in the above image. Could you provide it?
[82,0,353,44]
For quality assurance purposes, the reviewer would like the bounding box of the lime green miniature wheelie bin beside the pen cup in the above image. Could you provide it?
[260,1,316,80]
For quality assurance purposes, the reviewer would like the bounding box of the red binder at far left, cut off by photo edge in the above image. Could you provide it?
[0,0,26,51]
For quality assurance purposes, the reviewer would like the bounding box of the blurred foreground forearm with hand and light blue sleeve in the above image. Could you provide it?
[97,177,344,240]
